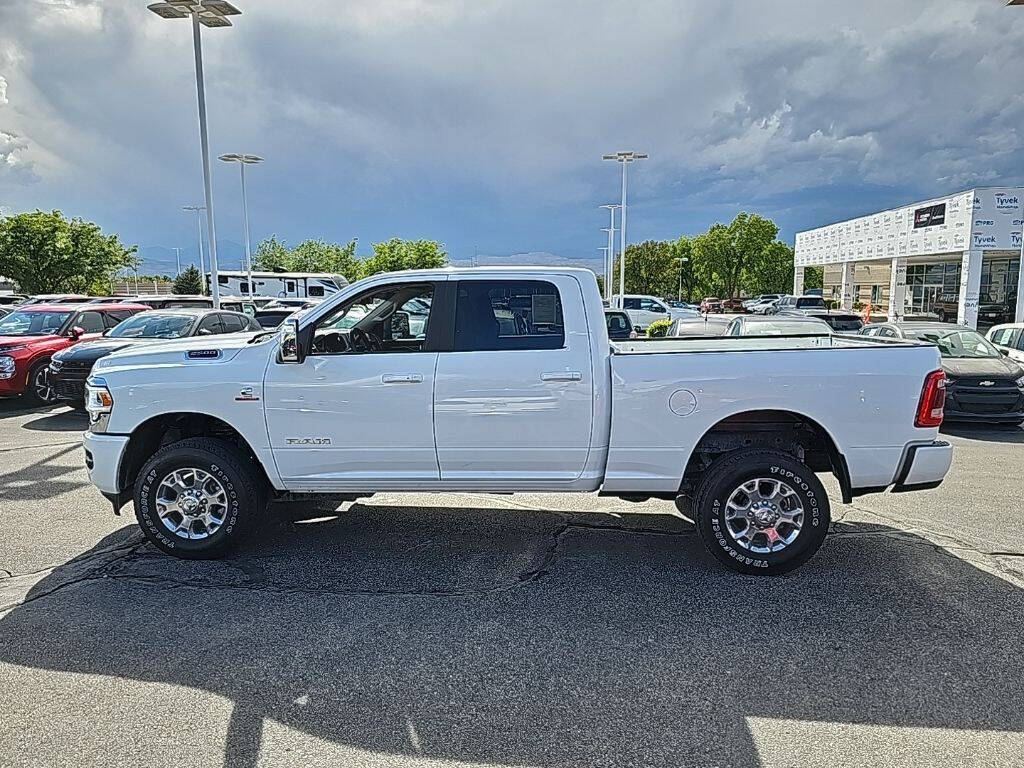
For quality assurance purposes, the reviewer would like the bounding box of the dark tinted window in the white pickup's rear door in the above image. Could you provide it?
[455,281,565,352]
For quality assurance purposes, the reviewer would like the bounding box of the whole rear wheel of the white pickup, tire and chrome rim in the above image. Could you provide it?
[693,450,830,575]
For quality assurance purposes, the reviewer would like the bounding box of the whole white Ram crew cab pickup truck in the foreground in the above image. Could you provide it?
[85,267,951,573]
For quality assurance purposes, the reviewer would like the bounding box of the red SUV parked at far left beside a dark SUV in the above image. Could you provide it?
[0,304,148,406]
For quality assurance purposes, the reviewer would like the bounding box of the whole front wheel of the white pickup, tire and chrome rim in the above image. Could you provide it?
[135,437,266,560]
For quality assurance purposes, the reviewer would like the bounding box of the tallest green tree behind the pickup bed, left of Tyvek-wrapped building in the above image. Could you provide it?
[692,212,778,298]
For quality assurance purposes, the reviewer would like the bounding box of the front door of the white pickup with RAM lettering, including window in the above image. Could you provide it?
[264,279,443,490]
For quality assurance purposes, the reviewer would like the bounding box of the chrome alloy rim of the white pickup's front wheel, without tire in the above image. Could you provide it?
[157,468,227,539]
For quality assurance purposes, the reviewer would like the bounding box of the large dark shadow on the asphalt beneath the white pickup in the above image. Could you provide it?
[0,502,1024,768]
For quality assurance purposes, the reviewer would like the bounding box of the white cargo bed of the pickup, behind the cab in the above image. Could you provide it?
[605,336,940,492]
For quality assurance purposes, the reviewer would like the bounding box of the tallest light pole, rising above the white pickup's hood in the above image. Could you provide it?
[148,0,242,309]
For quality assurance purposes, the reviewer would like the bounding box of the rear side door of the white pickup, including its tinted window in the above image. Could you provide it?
[434,275,594,487]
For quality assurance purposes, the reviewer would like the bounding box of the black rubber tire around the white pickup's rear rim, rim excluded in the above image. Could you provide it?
[693,449,831,575]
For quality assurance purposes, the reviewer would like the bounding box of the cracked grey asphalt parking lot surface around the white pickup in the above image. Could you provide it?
[0,402,1024,768]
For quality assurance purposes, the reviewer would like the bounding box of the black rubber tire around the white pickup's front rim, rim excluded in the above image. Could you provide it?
[135,437,267,560]
